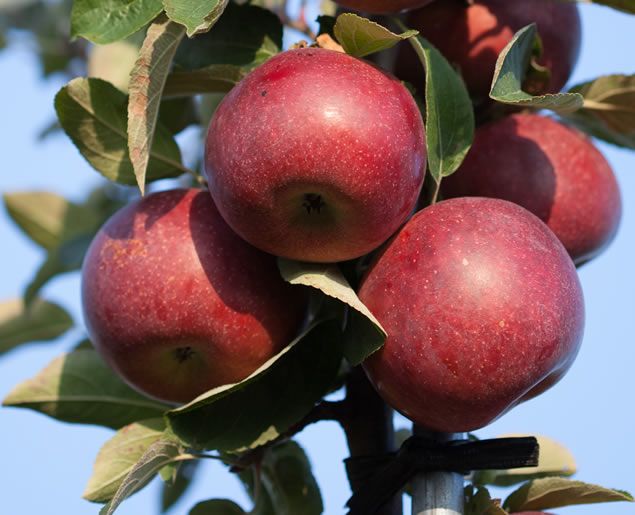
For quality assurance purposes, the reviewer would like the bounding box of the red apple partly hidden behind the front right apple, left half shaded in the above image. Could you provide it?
[441,114,622,264]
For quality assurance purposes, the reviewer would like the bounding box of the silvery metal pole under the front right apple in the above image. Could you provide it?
[411,427,465,515]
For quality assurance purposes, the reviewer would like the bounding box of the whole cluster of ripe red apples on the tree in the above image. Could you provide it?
[82,0,621,432]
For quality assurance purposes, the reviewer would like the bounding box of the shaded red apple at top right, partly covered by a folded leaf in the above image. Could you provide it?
[396,0,582,100]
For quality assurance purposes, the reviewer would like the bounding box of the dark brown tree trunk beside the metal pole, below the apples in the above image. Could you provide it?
[340,367,403,515]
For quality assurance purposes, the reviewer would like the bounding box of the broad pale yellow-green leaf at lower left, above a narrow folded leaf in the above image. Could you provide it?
[82,418,165,503]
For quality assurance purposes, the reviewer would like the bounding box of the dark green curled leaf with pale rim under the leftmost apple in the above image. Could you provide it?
[167,321,342,451]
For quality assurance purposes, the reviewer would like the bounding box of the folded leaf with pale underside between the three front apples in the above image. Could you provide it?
[278,258,387,365]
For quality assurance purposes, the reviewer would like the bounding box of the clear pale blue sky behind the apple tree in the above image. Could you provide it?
[0,5,635,515]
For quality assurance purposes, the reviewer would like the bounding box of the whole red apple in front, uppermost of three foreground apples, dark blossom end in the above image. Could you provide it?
[205,48,426,262]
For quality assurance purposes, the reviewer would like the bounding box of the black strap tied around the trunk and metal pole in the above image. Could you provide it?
[345,436,539,515]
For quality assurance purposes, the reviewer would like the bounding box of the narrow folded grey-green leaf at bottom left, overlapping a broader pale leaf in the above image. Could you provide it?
[99,438,196,515]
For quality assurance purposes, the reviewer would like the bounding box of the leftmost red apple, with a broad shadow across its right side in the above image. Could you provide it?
[82,190,306,402]
